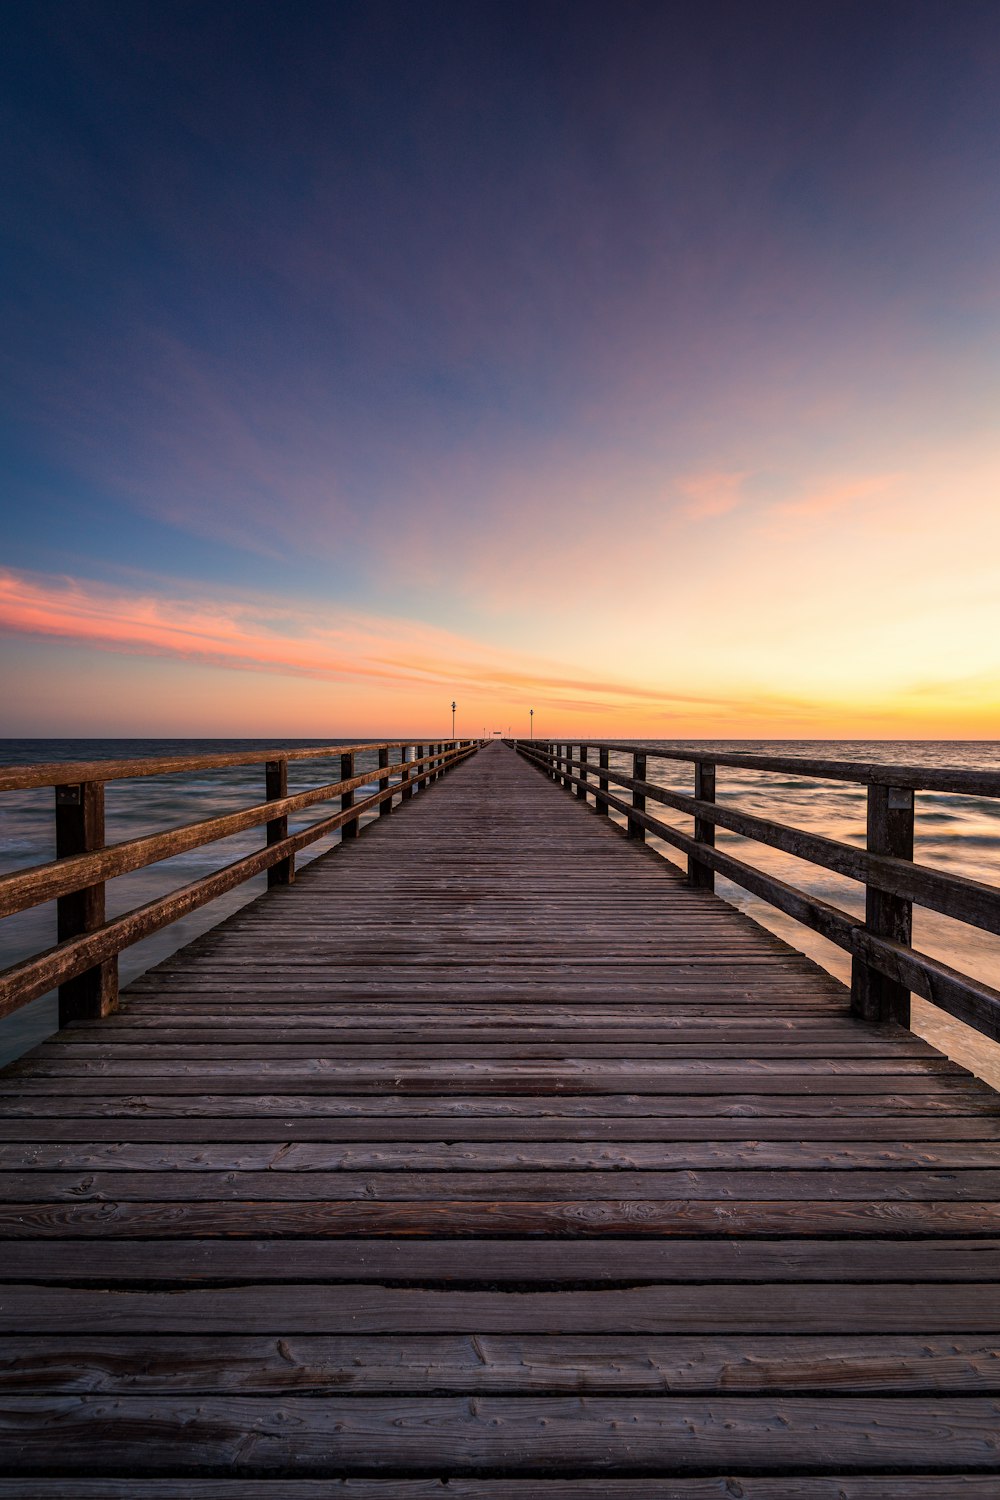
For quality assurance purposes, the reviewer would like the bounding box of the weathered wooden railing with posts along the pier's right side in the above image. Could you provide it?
[513,740,1000,1041]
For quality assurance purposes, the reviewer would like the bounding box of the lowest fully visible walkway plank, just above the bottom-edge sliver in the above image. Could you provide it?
[0,1395,1000,1478]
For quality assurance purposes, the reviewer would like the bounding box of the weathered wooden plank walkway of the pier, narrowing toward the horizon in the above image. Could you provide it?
[0,746,1000,1500]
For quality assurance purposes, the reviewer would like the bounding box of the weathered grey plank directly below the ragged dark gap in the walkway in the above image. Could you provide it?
[0,1284,1000,1335]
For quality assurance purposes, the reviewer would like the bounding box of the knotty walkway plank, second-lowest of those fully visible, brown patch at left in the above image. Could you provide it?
[0,1332,999,1392]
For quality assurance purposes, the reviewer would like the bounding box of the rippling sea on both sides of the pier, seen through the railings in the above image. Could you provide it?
[0,735,1000,1089]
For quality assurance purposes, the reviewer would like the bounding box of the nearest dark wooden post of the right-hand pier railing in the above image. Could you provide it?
[850,783,913,1026]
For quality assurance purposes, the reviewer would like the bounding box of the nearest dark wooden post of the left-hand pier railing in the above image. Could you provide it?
[55,782,118,1026]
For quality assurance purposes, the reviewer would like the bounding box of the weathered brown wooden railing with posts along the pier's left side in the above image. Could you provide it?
[0,740,480,1026]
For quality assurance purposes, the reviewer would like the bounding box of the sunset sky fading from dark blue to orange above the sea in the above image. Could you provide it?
[0,0,1000,741]
